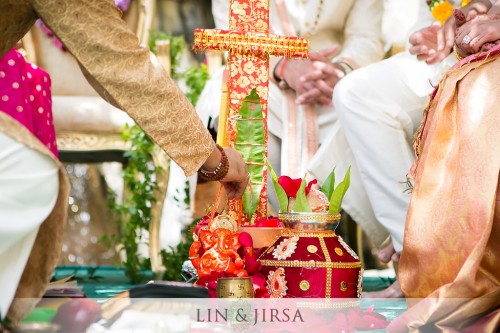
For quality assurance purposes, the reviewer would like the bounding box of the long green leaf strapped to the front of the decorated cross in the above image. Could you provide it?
[234,89,266,219]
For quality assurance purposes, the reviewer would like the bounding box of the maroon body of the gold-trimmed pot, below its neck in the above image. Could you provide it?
[259,231,362,298]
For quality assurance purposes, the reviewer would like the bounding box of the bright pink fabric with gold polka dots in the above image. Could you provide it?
[0,49,57,157]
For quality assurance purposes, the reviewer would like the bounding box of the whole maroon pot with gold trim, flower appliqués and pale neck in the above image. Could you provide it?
[259,213,363,298]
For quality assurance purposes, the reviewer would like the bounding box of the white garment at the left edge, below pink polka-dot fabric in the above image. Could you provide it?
[0,133,59,318]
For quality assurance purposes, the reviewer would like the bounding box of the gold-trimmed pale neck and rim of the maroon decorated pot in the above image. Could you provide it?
[278,212,340,231]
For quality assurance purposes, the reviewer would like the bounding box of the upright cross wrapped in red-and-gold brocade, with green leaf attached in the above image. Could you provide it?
[193,0,309,224]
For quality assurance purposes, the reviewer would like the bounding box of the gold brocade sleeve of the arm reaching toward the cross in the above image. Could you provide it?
[30,0,215,175]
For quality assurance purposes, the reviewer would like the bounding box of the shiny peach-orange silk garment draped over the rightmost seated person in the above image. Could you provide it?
[388,47,500,332]
